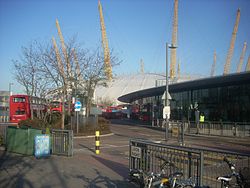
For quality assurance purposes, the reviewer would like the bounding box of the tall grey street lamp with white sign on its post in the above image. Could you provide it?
[163,43,177,141]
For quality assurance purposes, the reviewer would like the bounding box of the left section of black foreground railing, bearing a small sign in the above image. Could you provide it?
[129,139,203,185]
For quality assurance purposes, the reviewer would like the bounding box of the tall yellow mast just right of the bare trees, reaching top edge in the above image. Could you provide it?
[98,0,112,81]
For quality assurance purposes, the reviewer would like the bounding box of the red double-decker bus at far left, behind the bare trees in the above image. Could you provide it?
[10,95,47,123]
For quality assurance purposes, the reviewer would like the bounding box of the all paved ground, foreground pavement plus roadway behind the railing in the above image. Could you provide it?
[0,123,250,188]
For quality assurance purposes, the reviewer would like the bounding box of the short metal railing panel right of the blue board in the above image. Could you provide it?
[51,129,73,156]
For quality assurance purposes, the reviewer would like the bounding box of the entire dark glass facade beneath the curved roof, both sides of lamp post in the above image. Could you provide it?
[134,84,250,122]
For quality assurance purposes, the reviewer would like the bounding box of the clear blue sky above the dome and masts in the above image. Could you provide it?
[0,0,250,92]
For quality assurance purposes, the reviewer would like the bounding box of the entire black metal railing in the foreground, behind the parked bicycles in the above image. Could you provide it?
[129,139,250,188]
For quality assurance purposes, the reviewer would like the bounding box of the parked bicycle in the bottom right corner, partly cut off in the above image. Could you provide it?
[216,157,250,188]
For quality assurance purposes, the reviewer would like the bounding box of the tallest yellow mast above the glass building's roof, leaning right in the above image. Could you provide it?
[223,9,240,75]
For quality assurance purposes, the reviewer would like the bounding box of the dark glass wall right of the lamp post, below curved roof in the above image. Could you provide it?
[171,85,250,122]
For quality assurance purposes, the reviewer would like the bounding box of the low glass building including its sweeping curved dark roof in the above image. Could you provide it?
[118,72,250,122]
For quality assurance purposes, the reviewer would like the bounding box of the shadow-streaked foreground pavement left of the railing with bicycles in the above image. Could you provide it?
[0,150,134,188]
